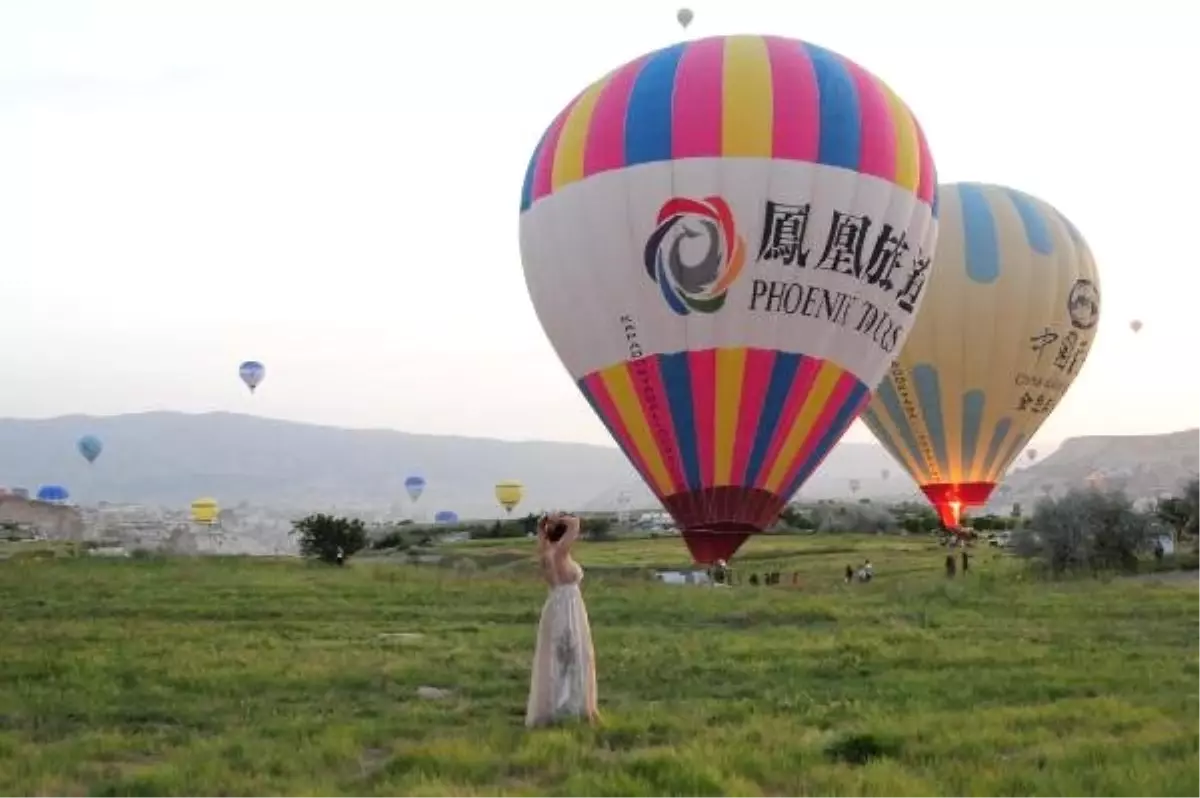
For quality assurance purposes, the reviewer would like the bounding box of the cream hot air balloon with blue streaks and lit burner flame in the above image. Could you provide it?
[863,184,1100,528]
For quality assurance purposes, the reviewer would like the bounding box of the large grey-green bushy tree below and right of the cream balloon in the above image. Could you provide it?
[1013,490,1154,575]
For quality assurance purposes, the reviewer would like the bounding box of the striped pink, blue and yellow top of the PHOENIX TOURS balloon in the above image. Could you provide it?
[521,36,937,211]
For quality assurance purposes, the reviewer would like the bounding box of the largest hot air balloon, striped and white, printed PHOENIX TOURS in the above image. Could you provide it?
[521,36,937,563]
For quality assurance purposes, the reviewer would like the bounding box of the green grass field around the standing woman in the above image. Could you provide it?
[0,538,1200,798]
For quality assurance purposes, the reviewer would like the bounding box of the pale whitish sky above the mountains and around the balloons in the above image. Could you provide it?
[0,0,1200,448]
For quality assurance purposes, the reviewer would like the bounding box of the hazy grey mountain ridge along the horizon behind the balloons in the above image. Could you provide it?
[0,410,1200,518]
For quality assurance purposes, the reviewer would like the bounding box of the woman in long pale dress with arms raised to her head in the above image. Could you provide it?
[526,515,599,727]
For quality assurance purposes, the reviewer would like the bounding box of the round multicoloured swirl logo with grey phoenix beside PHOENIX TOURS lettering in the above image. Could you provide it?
[644,197,746,316]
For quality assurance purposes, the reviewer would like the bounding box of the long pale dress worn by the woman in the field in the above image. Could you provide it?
[526,560,598,727]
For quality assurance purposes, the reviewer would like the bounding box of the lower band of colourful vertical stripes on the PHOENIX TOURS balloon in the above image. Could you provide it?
[578,348,868,500]
